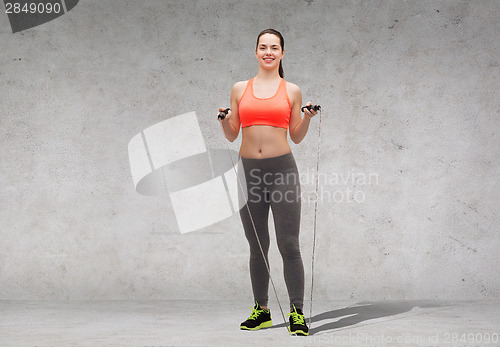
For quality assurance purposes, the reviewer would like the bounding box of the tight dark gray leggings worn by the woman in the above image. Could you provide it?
[238,152,304,309]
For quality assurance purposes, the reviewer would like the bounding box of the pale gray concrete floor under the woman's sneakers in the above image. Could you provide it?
[0,300,500,346]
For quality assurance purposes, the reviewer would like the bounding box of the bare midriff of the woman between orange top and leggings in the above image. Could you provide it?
[239,125,292,159]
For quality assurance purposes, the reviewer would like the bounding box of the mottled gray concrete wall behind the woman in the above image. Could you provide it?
[0,0,500,303]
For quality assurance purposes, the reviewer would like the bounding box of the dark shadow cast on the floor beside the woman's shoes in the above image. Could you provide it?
[272,301,448,335]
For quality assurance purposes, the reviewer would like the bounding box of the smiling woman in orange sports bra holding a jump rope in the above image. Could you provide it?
[219,29,317,335]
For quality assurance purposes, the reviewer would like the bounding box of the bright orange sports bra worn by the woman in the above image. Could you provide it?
[238,78,292,129]
